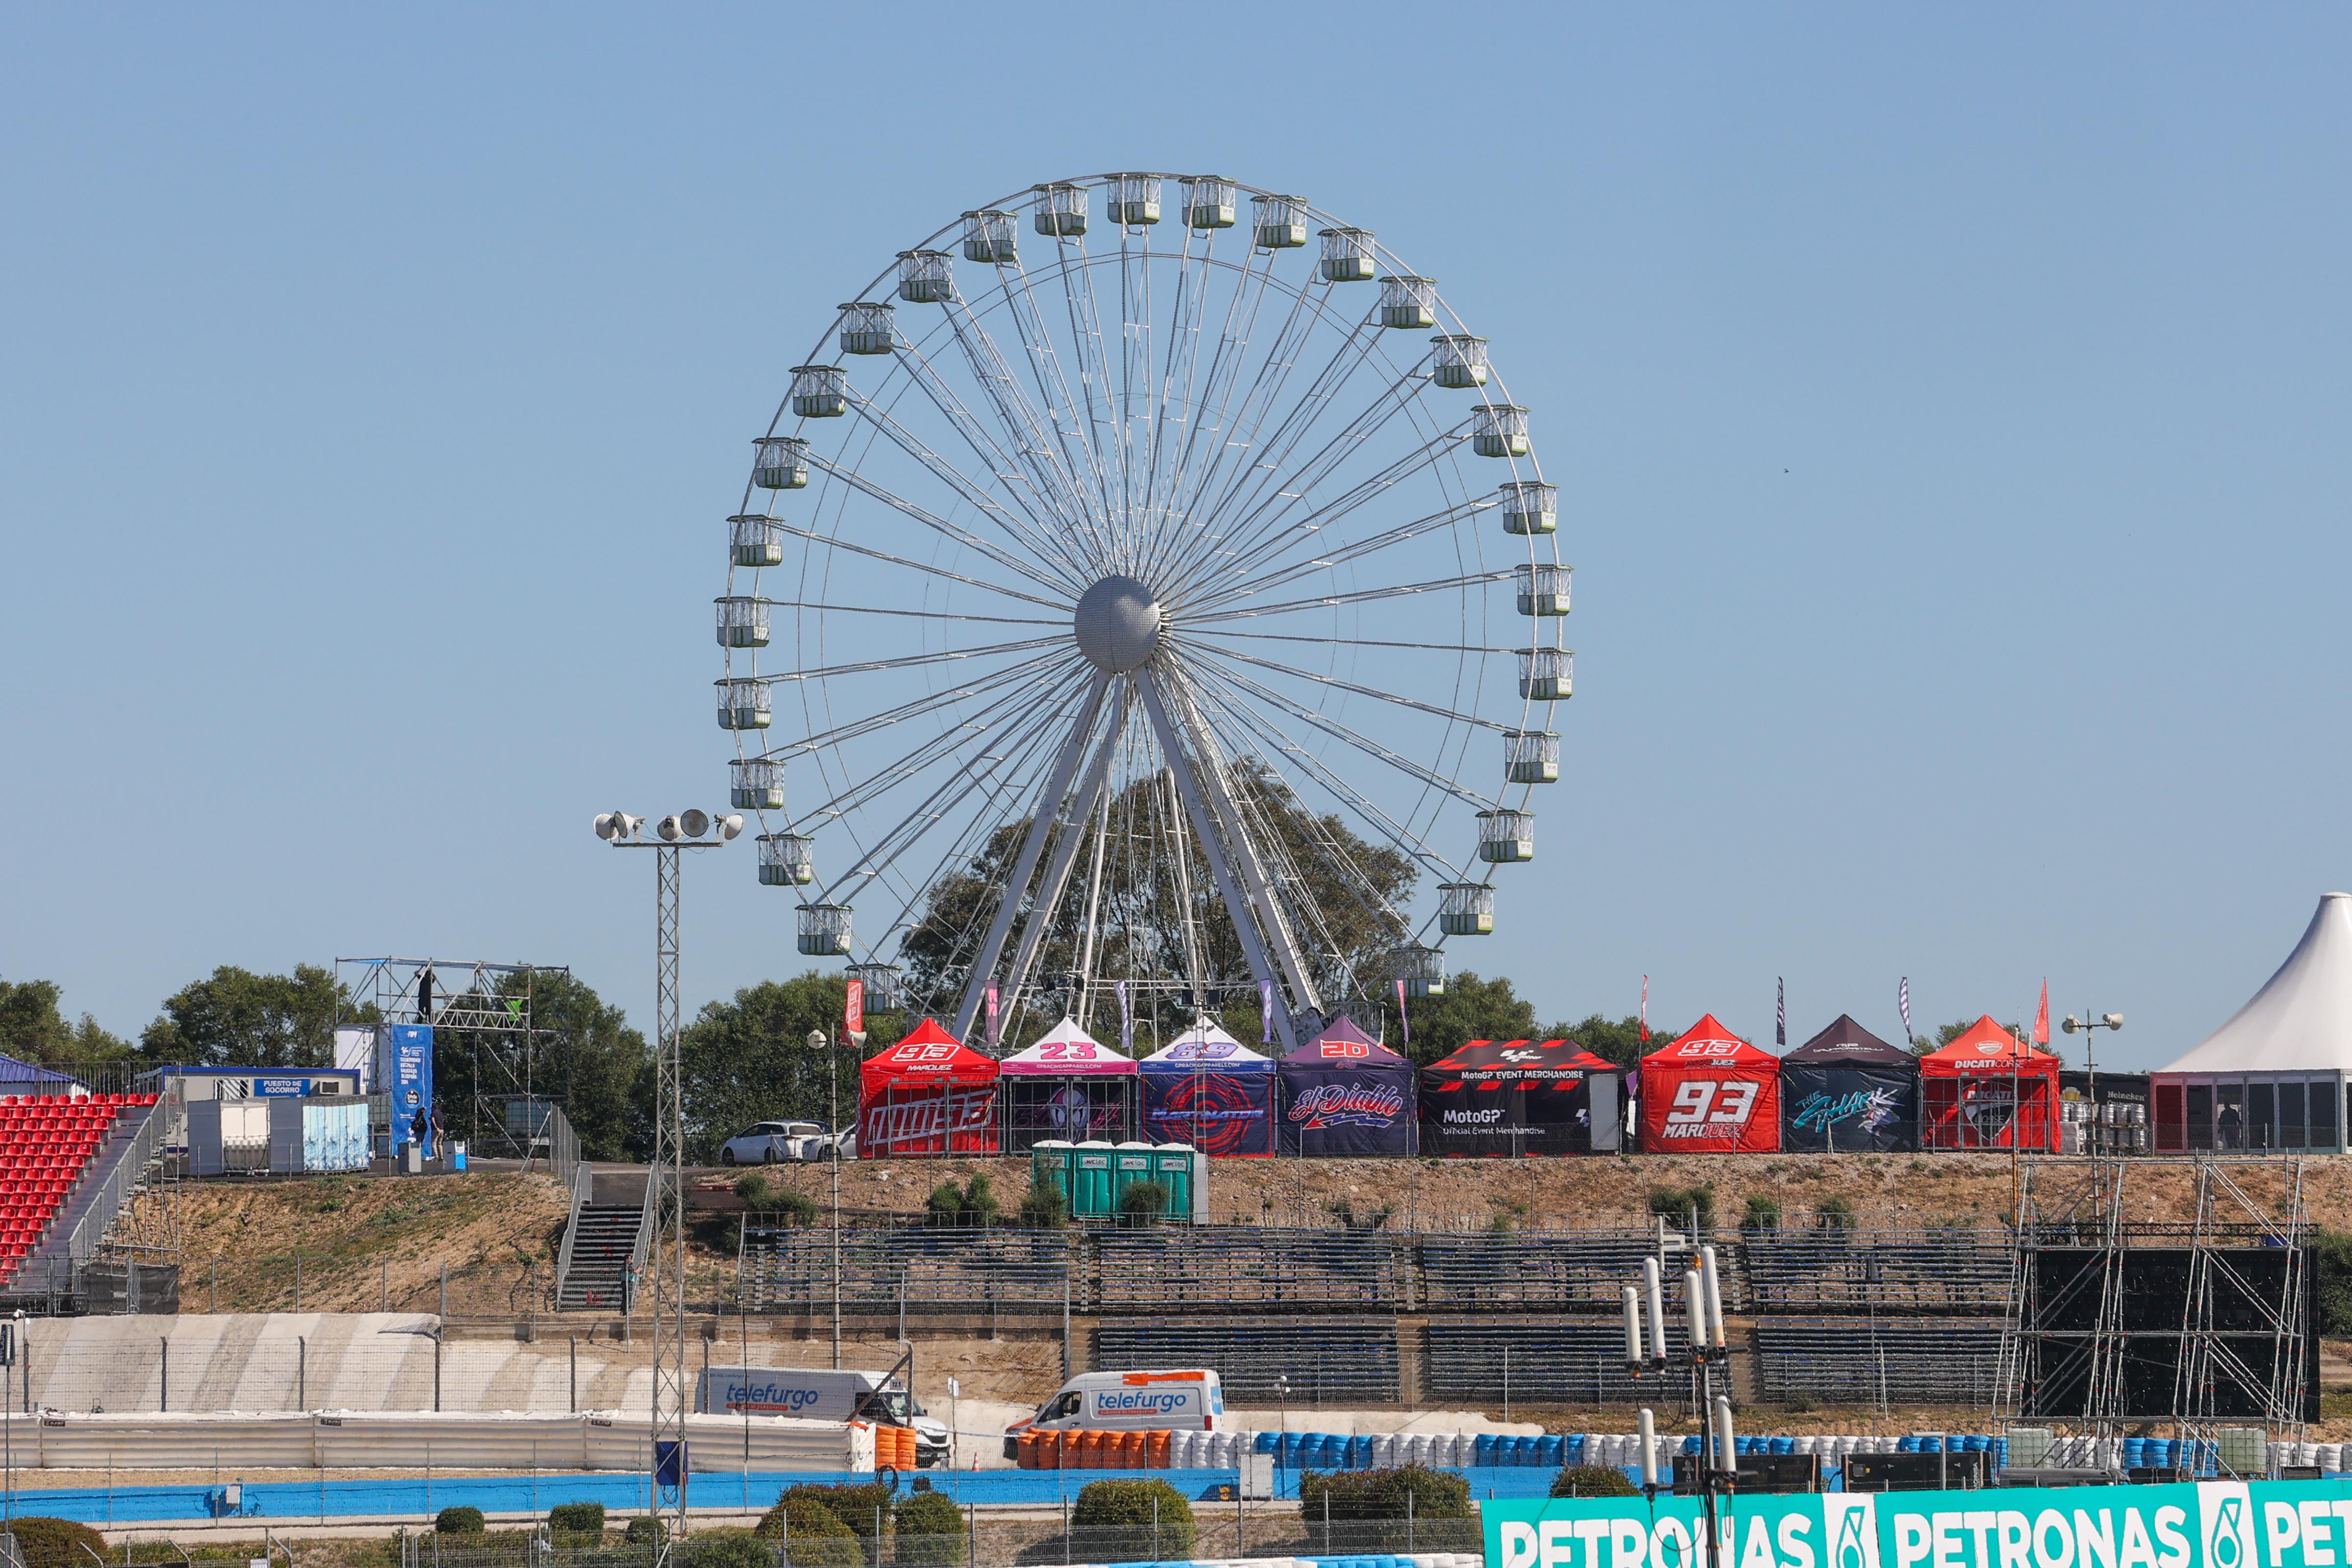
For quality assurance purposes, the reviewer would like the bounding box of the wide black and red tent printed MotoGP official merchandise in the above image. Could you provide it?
[1421,1039,1618,1159]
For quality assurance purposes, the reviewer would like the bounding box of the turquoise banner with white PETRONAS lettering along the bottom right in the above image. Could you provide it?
[1479,1481,2352,1568]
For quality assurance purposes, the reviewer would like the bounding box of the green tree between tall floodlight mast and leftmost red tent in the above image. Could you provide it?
[682,969,906,1161]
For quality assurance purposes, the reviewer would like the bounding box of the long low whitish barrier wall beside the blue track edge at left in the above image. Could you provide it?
[12,1411,875,1474]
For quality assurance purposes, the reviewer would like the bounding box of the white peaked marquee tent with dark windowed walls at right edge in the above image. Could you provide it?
[2150,893,2352,1154]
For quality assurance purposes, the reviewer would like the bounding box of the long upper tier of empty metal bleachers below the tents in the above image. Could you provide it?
[738,1215,2013,1317]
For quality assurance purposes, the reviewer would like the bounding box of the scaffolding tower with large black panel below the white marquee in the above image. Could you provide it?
[1997,1156,2319,1455]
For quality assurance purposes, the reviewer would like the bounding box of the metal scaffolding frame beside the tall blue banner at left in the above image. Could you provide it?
[334,957,571,1159]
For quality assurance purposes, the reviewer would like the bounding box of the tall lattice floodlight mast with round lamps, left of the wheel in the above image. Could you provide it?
[595,811,743,1568]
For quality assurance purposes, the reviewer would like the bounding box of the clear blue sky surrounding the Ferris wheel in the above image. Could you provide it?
[0,5,2352,1065]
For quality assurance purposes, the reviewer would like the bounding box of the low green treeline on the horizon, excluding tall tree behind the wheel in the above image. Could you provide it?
[0,964,1672,1161]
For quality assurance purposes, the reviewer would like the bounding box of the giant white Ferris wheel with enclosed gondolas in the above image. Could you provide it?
[717,174,1571,1044]
